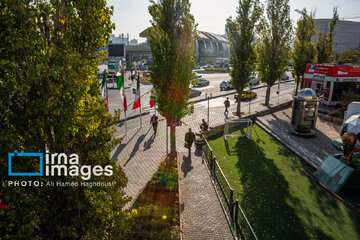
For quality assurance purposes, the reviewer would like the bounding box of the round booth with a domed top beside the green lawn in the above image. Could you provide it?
[291,88,320,129]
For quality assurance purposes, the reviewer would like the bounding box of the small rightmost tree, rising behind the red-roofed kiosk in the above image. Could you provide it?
[316,7,339,63]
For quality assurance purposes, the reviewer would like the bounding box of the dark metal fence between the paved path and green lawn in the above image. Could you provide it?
[201,135,258,240]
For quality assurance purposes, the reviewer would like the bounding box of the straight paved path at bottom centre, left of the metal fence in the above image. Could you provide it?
[178,153,233,240]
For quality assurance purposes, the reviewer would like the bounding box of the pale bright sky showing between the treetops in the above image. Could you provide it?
[107,0,360,42]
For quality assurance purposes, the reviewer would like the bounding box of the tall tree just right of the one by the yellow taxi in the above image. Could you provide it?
[256,0,292,106]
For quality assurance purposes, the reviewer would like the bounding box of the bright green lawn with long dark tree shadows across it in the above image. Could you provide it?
[209,125,360,240]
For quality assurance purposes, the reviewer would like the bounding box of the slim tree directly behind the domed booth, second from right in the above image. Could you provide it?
[292,8,316,95]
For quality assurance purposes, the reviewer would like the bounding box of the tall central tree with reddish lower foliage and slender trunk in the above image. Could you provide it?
[147,0,196,158]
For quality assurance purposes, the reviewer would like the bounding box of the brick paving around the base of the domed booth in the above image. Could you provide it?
[258,108,341,168]
